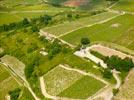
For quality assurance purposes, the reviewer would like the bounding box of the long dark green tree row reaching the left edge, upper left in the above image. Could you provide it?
[0,15,52,32]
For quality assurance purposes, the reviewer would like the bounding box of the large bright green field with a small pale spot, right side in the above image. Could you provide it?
[61,14,134,50]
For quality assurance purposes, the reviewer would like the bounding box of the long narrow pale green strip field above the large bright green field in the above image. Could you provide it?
[43,12,117,36]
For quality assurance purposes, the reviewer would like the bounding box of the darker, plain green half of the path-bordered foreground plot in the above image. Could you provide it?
[59,76,105,99]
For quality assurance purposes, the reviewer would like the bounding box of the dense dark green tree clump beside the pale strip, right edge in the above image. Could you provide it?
[104,56,134,72]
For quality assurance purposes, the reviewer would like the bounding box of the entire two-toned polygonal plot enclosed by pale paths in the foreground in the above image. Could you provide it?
[44,65,105,99]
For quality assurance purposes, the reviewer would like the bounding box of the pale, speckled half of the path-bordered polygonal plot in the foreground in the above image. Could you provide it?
[44,66,83,95]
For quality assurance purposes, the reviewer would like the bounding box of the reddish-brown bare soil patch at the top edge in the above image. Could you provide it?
[63,0,89,7]
